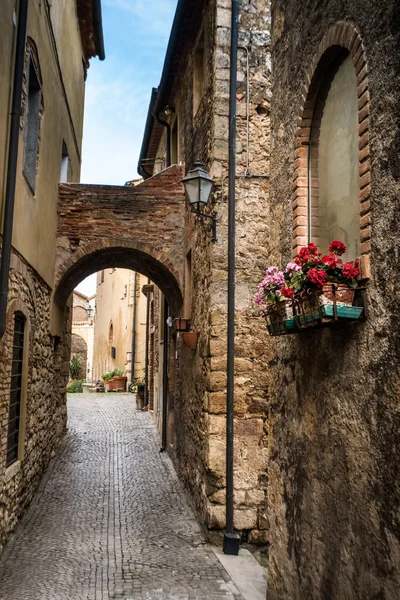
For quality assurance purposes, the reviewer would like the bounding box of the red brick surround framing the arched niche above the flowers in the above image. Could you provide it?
[292,22,371,277]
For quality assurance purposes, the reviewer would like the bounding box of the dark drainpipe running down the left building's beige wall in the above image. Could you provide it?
[0,0,29,339]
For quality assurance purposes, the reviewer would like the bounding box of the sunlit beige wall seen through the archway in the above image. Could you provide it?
[93,269,147,380]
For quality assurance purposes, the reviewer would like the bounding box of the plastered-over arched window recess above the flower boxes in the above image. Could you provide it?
[308,52,360,260]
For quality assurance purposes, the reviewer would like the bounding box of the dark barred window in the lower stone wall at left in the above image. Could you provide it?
[6,314,25,467]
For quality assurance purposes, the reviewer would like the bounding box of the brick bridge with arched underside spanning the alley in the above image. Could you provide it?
[55,166,184,311]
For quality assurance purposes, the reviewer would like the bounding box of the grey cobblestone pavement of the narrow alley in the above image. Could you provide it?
[0,394,242,600]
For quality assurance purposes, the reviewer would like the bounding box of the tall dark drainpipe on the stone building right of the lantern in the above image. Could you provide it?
[223,0,240,555]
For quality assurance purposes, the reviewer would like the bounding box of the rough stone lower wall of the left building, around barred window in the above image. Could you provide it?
[0,248,68,550]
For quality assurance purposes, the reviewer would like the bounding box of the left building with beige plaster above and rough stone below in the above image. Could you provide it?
[0,0,103,548]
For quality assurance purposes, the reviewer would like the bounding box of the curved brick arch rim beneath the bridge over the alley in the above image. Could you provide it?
[54,239,183,314]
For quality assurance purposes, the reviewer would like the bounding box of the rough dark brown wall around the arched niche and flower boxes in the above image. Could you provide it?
[268,0,400,600]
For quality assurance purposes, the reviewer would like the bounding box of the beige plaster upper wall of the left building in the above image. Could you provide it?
[0,0,84,287]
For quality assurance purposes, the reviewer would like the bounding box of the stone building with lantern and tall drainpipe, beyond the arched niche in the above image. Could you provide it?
[139,0,271,543]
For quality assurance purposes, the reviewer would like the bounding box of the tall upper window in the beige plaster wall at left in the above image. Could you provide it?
[23,54,41,193]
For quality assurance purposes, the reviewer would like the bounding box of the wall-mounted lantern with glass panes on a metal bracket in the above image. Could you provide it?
[182,160,217,242]
